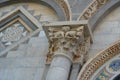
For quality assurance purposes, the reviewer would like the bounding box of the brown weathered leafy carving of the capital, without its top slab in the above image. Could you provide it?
[46,26,90,64]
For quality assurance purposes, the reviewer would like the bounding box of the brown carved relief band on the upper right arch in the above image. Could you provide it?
[78,0,109,20]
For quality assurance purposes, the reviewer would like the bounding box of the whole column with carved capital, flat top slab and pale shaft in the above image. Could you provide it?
[43,21,92,80]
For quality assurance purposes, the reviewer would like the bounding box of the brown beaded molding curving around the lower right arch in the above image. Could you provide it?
[77,41,120,80]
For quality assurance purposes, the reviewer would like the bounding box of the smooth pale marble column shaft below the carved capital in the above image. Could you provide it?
[46,52,72,80]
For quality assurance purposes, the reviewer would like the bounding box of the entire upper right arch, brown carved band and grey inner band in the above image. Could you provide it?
[78,0,120,31]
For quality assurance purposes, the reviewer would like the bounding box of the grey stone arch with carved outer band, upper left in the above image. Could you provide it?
[0,0,71,21]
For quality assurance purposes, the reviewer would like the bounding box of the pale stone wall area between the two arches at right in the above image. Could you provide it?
[89,7,120,58]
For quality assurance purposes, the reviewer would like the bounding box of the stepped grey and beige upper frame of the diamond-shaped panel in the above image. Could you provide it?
[0,7,42,30]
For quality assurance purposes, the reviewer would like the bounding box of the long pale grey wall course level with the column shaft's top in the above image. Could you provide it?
[0,57,46,69]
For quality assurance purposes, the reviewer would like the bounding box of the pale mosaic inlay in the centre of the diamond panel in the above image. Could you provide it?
[0,22,28,46]
